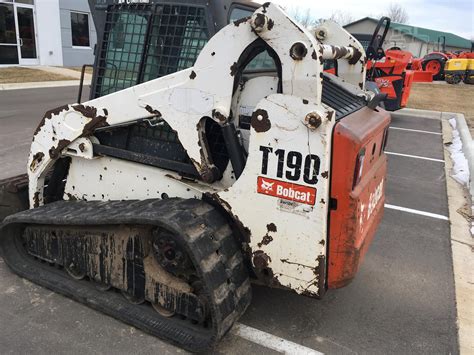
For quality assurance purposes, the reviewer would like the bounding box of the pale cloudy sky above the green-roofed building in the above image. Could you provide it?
[272,0,474,40]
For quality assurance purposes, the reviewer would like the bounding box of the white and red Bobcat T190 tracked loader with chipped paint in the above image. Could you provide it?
[0,0,390,351]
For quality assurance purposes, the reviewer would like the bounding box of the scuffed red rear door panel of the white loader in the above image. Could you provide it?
[328,108,390,288]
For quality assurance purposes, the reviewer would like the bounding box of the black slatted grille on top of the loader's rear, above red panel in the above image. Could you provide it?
[322,74,367,120]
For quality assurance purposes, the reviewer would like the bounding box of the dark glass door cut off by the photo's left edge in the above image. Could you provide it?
[0,3,19,65]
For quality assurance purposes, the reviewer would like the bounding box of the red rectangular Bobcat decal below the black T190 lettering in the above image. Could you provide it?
[257,176,316,206]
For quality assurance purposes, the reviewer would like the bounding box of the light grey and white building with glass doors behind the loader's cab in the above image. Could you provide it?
[0,0,97,66]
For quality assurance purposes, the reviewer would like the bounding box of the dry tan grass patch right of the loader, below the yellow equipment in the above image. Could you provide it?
[408,83,474,135]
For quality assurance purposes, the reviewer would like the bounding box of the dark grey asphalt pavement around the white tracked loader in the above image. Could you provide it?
[0,88,459,354]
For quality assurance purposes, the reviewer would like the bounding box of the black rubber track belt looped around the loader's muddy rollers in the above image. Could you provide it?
[0,199,251,352]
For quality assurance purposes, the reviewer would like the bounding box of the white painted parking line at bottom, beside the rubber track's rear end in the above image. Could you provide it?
[231,323,323,355]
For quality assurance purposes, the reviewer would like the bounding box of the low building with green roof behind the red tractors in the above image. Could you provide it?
[344,17,471,57]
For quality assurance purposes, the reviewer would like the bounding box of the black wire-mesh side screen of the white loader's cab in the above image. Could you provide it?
[94,4,209,97]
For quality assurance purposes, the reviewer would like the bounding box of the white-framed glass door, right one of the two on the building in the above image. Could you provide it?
[15,4,39,65]
